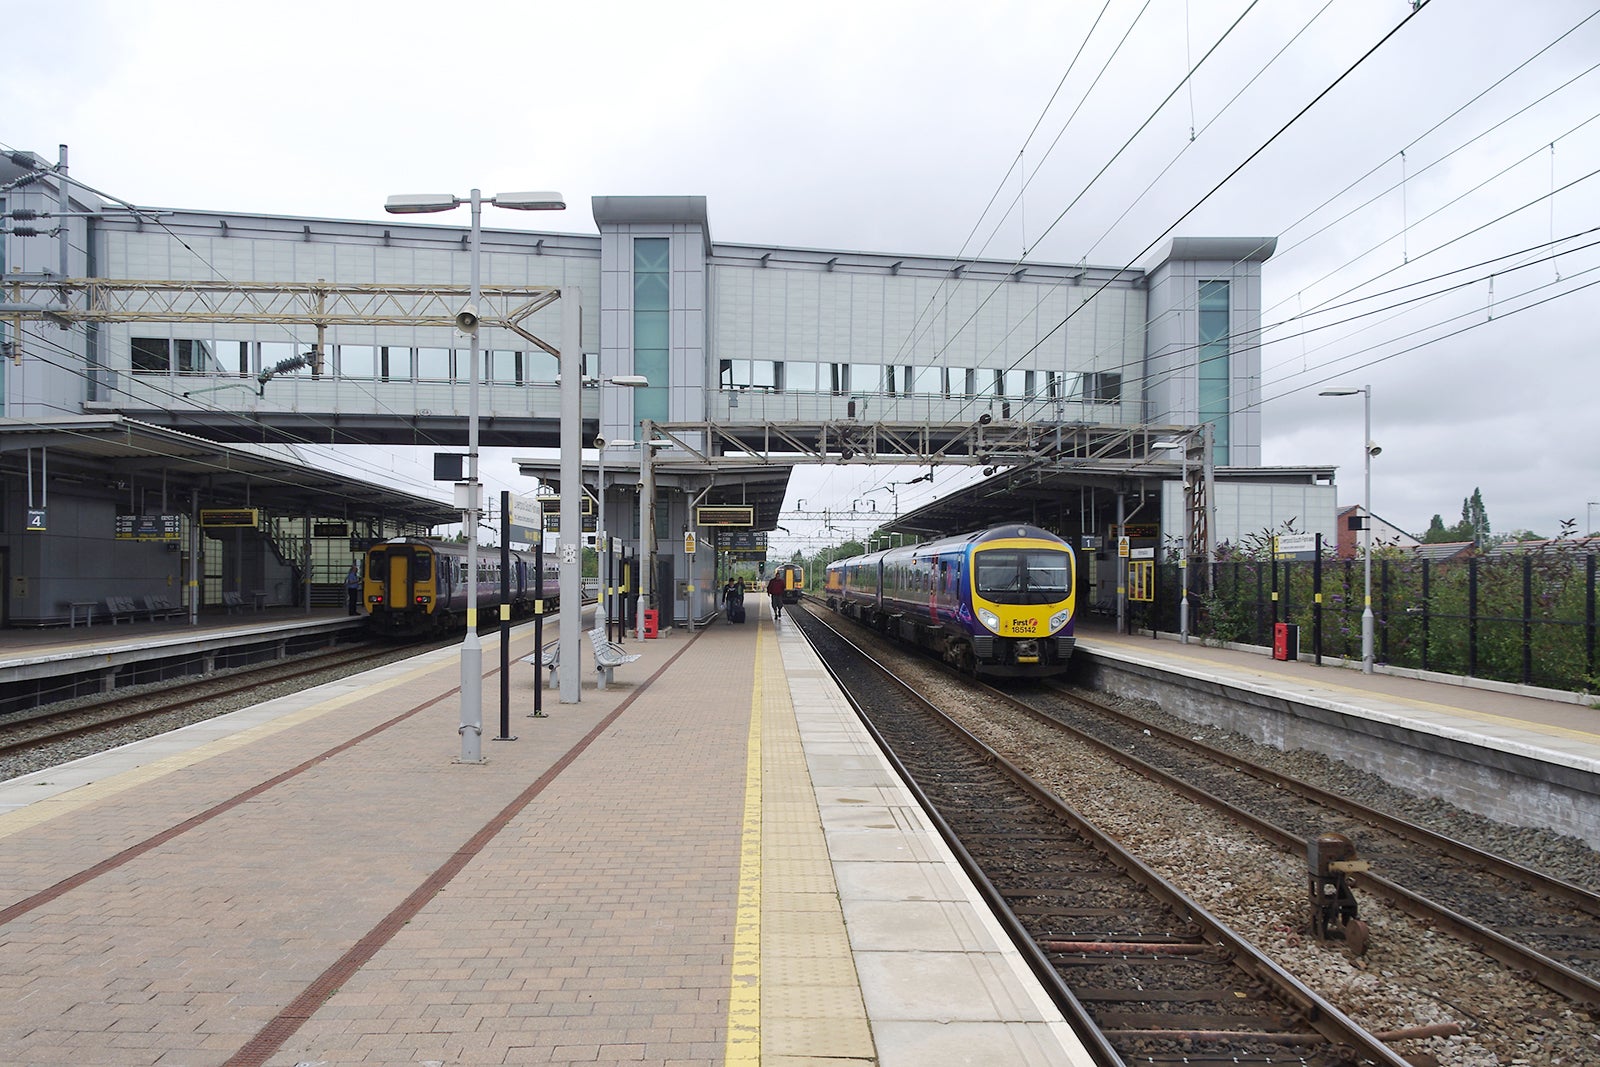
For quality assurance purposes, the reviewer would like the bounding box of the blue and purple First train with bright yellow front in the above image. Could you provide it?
[824,525,1077,677]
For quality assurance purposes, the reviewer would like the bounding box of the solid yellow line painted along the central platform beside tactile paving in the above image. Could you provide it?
[723,616,765,1065]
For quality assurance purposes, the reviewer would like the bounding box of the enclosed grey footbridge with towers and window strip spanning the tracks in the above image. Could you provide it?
[0,154,1333,630]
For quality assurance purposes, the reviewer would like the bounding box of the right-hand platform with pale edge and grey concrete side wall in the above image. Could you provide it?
[1074,624,1600,849]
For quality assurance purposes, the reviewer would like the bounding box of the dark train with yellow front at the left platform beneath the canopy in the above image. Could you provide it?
[362,537,560,637]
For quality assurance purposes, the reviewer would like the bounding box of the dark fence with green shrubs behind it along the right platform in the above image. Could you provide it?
[1130,542,1600,693]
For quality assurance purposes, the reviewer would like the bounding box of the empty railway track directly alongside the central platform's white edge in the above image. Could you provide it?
[792,613,1406,1067]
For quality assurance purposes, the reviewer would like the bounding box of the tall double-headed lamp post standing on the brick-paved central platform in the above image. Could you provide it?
[384,189,566,763]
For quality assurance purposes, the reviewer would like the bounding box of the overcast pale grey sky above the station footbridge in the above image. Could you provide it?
[0,0,1600,547]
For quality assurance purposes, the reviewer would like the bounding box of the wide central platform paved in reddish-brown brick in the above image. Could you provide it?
[0,597,1088,1067]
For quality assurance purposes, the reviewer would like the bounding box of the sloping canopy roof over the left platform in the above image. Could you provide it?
[0,414,461,526]
